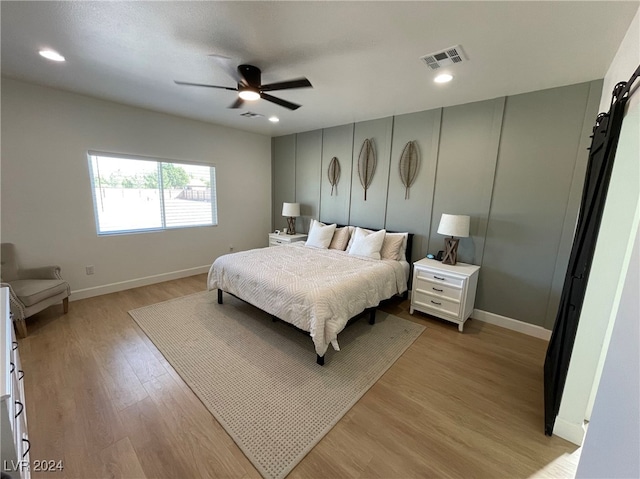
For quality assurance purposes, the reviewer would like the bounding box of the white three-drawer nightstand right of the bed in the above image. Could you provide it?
[409,258,480,332]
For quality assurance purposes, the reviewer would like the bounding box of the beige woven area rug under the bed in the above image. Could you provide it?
[129,292,424,478]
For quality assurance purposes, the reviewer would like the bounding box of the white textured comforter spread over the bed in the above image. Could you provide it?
[207,243,407,356]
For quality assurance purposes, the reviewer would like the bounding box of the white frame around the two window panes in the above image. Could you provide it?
[87,150,218,237]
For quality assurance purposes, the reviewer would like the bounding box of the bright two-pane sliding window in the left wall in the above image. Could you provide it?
[89,151,218,235]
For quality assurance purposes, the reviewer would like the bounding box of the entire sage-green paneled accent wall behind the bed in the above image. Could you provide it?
[273,81,602,329]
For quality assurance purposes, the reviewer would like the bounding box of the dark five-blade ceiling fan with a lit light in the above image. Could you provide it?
[174,65,313,110]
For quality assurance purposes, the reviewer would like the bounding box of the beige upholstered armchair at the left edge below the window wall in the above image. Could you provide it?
[0,243,71,337]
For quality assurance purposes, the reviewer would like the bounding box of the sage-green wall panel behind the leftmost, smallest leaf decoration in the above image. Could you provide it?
[320,123,353,225]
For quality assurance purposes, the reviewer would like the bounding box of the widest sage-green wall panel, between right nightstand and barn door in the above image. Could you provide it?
[476,83,589,326]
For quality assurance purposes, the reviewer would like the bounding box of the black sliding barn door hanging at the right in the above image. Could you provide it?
[544,67,640,436]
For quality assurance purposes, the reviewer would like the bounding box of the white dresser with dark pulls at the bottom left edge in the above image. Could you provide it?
[0,288,30,479]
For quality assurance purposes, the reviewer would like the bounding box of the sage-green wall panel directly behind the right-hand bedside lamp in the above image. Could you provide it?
[429,98,504,264]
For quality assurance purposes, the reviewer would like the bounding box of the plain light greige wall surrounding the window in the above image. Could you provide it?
[1,78,272,299]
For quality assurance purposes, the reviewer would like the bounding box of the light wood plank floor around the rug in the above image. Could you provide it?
[20,275,579,479]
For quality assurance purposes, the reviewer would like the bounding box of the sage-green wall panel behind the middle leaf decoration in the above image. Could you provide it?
[349,117,393,228]
